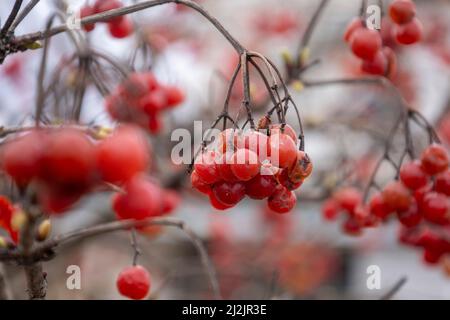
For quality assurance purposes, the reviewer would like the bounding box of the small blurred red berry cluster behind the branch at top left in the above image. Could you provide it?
[80,0,134,39]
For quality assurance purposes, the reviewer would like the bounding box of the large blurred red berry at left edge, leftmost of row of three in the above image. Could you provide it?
[2,130,46,186]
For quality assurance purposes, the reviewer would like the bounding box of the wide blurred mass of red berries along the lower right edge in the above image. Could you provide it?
[322,144,450,262]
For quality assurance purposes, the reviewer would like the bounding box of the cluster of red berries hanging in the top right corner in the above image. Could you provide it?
[344,0,422,77]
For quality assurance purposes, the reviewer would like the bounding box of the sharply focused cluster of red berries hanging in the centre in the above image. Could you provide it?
[191,124,312,213]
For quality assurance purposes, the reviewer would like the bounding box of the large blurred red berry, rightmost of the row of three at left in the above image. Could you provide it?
[97,125,150,183]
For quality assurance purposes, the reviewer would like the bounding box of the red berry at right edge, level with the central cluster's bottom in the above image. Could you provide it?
[420,192,450,224]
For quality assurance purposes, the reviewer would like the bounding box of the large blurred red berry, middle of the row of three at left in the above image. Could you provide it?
[40,129,95,187]
